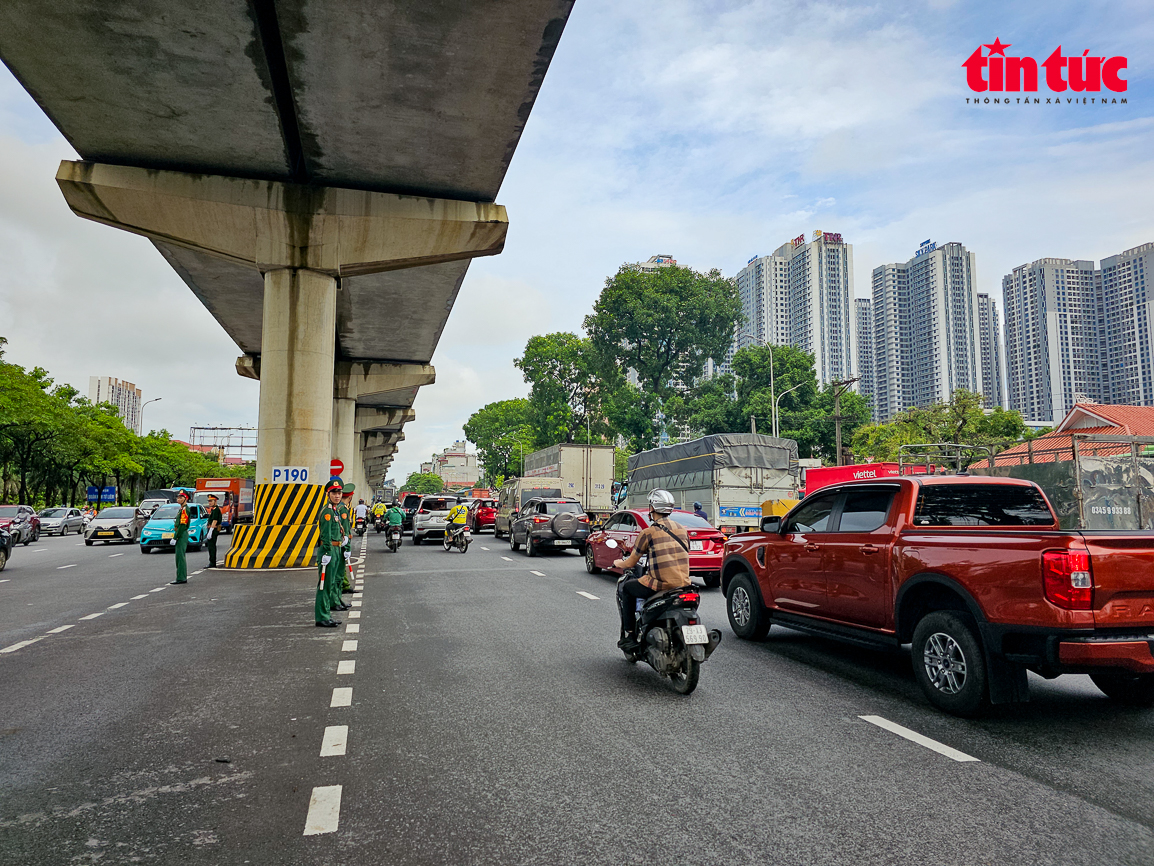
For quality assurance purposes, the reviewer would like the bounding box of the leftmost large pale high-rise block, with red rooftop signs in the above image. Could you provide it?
[719,231,856,385]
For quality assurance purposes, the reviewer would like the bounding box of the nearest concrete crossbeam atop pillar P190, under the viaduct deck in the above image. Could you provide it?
[57,160,509,277]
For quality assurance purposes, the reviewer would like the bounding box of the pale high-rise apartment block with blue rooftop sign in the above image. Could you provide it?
[872,240,983,421]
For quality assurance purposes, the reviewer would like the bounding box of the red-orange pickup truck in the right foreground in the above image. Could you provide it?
[721,476,1154,716]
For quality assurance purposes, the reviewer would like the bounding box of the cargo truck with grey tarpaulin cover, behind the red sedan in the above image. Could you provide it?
[624,433,799,532]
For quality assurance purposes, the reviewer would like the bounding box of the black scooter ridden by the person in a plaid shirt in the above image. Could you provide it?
[606,538,721,695]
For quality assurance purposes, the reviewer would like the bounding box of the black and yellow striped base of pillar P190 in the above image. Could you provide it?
[224,484,324,568]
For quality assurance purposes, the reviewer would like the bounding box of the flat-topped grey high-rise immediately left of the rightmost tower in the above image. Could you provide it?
[1002,259,1115,424]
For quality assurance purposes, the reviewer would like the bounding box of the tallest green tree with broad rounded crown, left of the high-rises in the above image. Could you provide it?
[585,264,742,401]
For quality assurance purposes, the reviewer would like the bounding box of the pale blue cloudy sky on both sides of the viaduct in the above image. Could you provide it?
[0,0,1154,478]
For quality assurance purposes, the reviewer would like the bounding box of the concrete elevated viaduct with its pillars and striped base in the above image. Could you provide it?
[0,0,572,567]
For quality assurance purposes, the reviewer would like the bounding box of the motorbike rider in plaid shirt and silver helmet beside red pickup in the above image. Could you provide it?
[613,490,690,649]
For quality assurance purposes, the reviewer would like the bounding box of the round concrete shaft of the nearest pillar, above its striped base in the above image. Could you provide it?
[256,268,336,484]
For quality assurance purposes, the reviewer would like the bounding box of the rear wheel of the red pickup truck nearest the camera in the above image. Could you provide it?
[909,611,989,716]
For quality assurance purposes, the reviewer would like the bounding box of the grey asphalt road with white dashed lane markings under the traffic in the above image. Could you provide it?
[0,535,1154,866]
